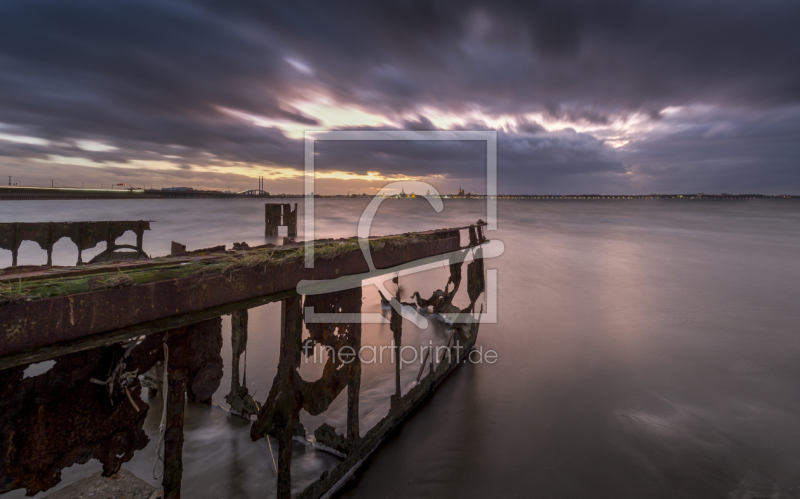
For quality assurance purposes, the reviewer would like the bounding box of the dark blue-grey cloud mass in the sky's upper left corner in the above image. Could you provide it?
[0,0,316,127]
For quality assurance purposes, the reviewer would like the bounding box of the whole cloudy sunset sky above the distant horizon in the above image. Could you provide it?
[0,0,800,194]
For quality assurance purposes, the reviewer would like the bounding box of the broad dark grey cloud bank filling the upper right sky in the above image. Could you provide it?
[254,0,800,116]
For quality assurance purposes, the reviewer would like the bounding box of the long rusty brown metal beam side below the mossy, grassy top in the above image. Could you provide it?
[0,230,460,357]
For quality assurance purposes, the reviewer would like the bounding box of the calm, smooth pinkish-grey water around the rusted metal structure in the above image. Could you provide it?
[0,199,800,498]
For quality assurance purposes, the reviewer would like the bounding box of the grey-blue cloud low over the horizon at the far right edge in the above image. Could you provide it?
[621,106,800,194]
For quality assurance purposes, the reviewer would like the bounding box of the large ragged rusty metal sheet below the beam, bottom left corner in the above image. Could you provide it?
[0,345,149,495]
